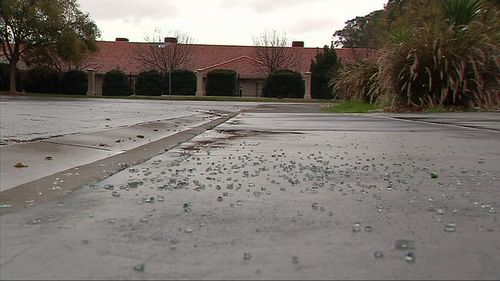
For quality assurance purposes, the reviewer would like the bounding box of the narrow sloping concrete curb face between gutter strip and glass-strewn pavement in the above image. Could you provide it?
[0,112,239,213]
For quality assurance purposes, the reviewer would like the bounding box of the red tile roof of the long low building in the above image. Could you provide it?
[85,41,376,79]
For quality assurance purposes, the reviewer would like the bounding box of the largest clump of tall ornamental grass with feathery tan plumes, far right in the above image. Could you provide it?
[378,22,500,108]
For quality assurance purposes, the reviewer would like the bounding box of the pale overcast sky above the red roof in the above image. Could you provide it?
[79,0,387,47]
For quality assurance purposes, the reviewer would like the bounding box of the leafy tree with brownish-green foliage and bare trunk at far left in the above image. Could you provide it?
[0,0,98,93]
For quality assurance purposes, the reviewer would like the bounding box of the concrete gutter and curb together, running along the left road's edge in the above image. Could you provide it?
[0,110,241,215]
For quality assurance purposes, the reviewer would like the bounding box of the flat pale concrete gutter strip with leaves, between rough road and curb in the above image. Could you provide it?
[0,110,230,191]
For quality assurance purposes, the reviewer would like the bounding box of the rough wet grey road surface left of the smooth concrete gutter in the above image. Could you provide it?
[0,95,256,145]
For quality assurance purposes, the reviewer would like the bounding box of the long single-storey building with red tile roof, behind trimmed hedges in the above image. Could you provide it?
[88,37,371,97]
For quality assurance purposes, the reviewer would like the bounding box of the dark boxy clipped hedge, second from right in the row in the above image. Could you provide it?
[206,69,238,96]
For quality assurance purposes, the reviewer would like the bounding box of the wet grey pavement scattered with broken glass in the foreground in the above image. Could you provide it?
[0,100,500,279]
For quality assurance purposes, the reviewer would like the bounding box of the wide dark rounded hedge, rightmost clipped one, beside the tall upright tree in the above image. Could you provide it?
[263,70,305,98]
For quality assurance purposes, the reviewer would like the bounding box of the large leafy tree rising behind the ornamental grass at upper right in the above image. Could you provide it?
[333,0,500,49]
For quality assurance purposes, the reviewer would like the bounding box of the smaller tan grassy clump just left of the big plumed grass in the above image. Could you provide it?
[331,59,380,103]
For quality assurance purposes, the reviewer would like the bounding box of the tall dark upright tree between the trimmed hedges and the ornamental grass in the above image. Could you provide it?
[311,46,340,99]
